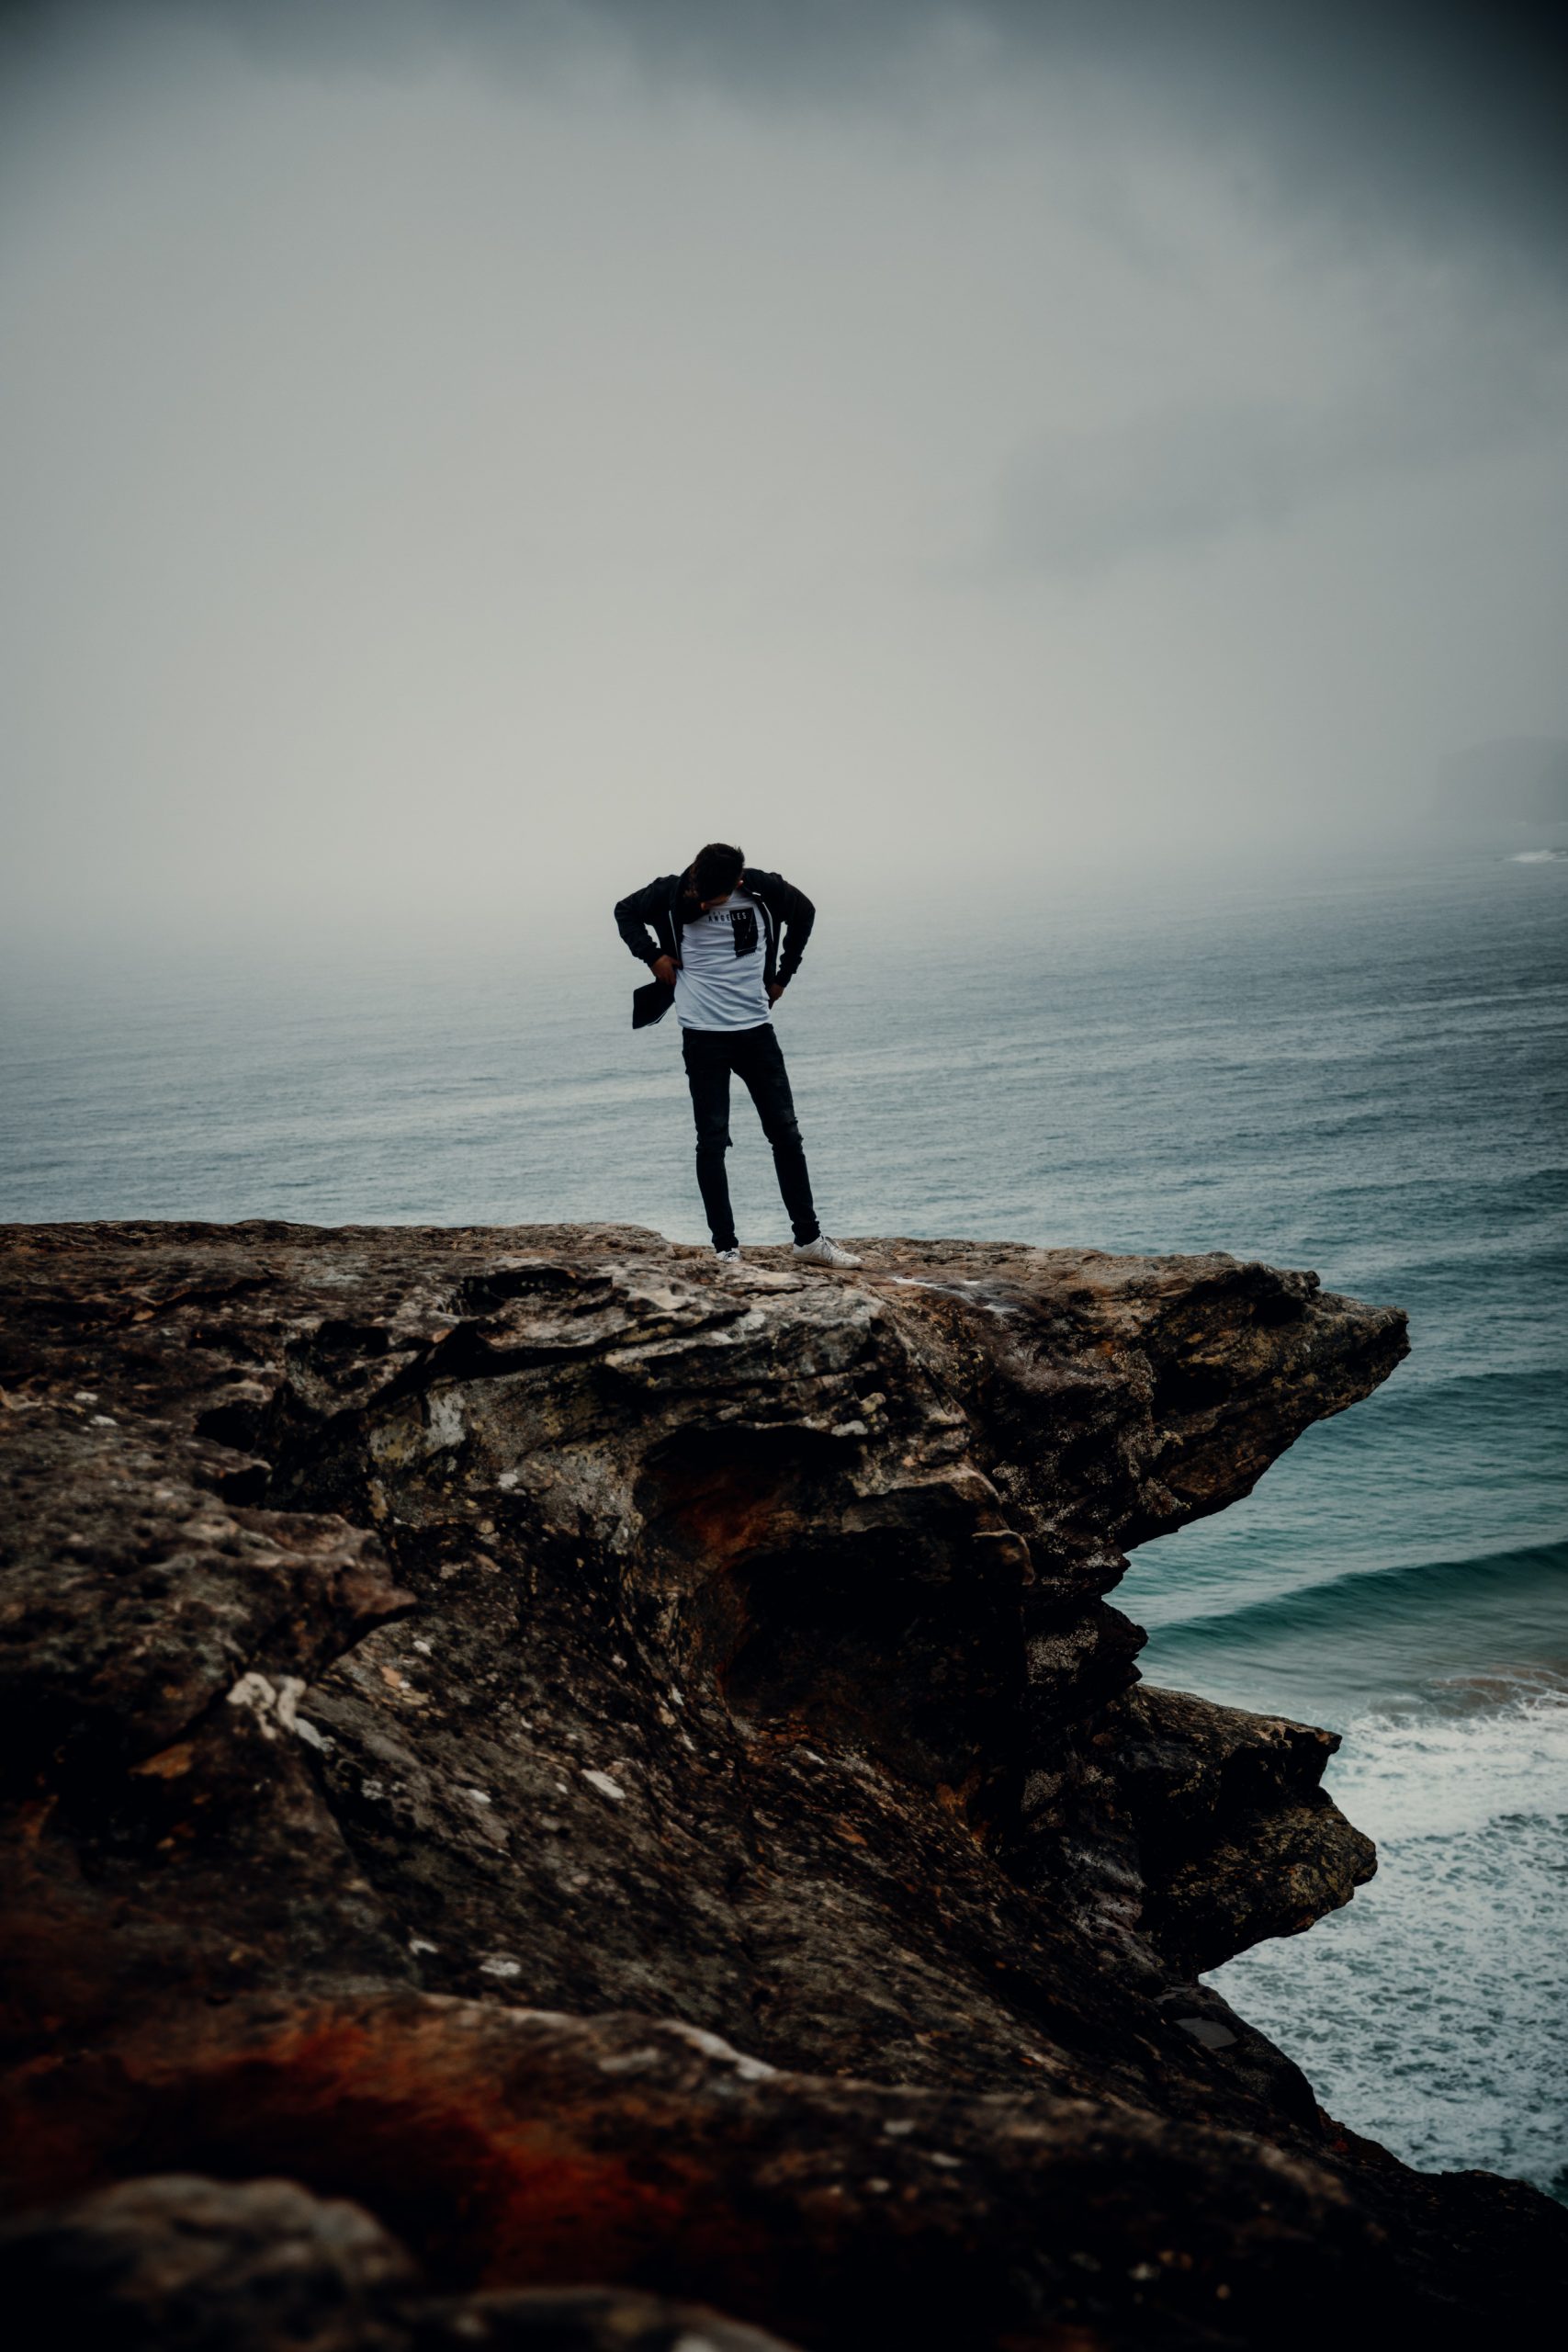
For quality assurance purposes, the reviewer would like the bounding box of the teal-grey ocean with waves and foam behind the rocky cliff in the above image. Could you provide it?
[0,842,1568,2197]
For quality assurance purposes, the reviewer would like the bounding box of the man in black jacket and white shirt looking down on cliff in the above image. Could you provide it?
[616,842,861,1265]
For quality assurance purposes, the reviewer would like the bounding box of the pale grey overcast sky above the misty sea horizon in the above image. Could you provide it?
[0,0,1568,929]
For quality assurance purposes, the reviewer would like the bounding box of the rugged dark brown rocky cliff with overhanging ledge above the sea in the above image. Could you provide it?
[0,1226,1568,2352]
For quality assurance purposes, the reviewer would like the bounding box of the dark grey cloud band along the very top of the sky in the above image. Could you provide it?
[0,0,1568,268]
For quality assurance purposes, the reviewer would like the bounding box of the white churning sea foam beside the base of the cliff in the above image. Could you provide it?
[1215,1672,1568,2197]
